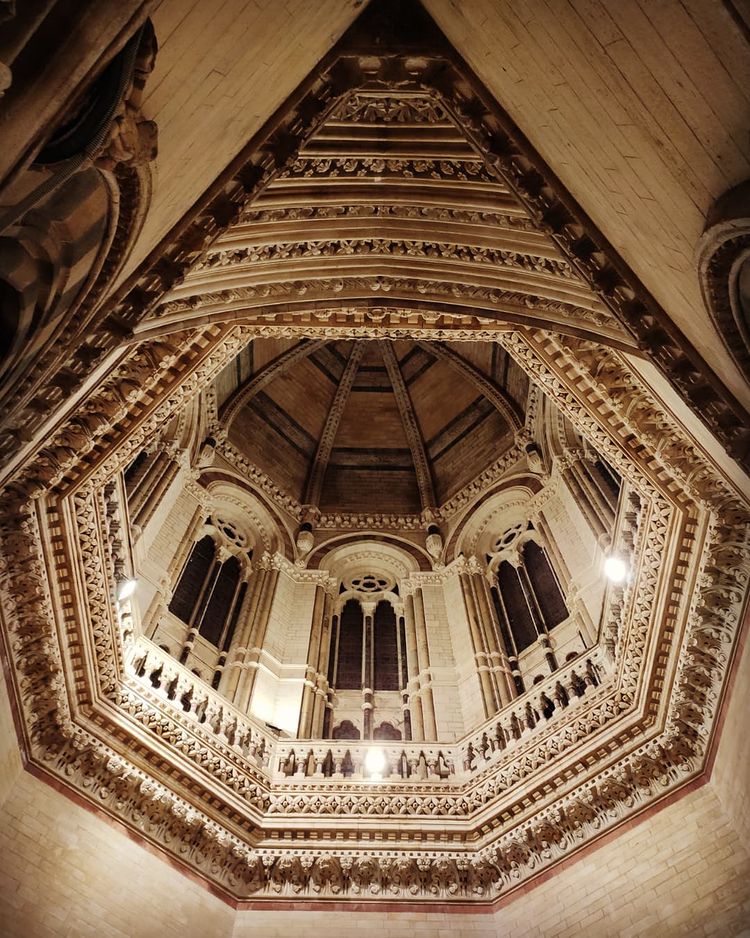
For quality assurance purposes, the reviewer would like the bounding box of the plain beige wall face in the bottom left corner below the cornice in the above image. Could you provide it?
[0,773,234,938]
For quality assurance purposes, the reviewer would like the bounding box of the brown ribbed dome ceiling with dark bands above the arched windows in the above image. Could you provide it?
[216,339,528,514]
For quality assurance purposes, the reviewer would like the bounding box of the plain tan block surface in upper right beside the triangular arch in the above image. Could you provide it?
[425,0,750,406]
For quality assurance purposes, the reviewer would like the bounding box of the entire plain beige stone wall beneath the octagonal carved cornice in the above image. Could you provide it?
[0,620,750,938]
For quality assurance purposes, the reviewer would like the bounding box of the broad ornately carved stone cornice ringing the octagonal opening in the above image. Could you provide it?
[0,312,750,901]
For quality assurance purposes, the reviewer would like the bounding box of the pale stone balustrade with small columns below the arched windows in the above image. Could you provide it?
[127,636,607,784]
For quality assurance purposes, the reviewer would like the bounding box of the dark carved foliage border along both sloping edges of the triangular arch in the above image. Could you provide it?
[2,4,750,478]
